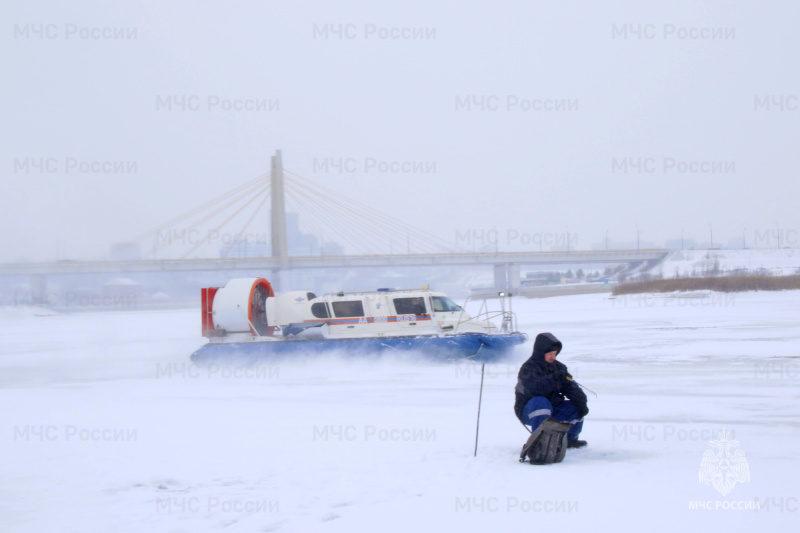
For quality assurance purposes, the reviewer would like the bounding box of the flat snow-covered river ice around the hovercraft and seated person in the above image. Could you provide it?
[0,291,800,533]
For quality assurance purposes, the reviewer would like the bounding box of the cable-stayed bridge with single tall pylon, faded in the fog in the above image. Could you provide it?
[0,151,668,288]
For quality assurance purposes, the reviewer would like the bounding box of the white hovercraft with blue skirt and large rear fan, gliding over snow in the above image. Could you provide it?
[191,278,527,365]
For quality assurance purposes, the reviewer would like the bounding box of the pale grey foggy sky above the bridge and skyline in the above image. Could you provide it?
[0,1,800,262]
